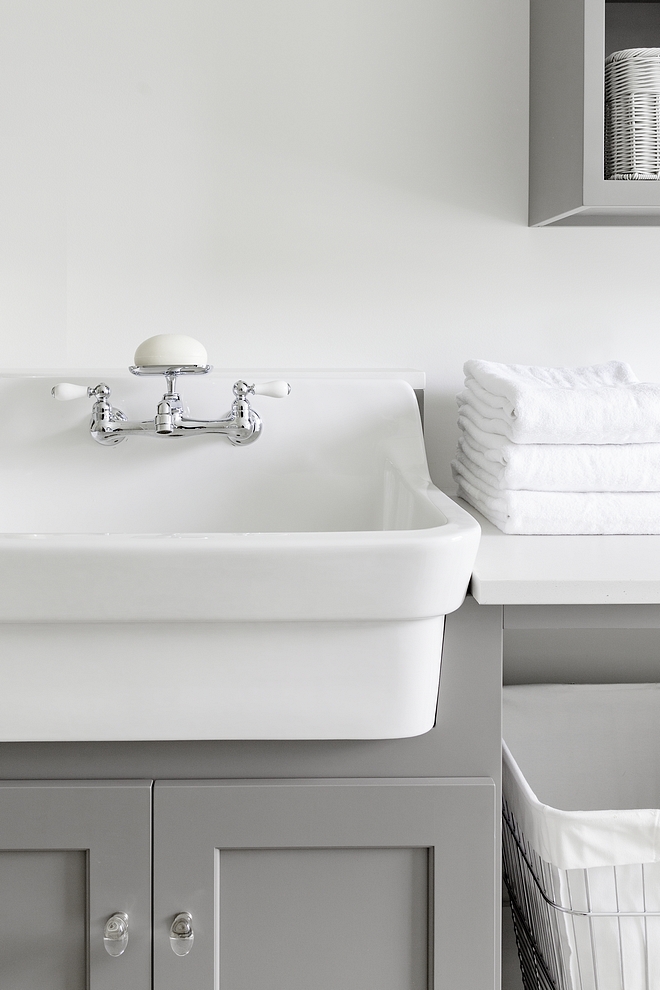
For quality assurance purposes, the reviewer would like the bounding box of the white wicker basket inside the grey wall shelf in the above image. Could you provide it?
[605,48,660,179]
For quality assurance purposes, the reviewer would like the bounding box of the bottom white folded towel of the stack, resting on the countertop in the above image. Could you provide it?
[455,464,660,536]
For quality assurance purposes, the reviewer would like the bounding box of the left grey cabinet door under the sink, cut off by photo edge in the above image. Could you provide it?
[0,781,151,990]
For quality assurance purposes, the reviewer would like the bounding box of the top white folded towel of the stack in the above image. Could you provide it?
[457,361,660,444]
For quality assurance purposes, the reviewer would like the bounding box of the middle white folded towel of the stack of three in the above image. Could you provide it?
[456,432,660,492]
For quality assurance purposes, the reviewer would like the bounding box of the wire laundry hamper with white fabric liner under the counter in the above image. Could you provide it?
[503,684,660,990]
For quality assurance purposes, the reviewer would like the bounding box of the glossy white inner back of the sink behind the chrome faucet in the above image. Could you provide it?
[0,372,434,533]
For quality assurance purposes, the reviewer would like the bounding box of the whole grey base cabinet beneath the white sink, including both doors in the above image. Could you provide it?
[0,599,502,990]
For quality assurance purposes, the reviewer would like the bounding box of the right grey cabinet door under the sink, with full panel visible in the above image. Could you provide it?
[154,778,497,990]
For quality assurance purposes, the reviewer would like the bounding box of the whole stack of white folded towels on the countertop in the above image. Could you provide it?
[452,361,660,534]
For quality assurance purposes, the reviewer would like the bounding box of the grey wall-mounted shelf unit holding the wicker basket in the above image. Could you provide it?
[529,0,660,227]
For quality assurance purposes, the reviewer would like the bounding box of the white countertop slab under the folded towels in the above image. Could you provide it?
[456,499,660,605]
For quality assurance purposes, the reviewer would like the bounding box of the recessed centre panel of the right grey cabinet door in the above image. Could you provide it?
[215,848,429,990]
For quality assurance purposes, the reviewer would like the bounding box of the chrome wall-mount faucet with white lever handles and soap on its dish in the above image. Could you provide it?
[52,334,291,447]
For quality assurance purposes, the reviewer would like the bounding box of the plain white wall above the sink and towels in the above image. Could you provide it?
[0,0,660,487]
